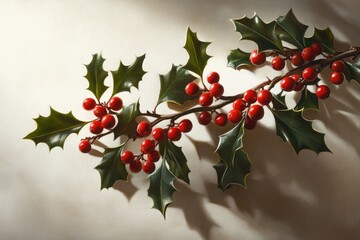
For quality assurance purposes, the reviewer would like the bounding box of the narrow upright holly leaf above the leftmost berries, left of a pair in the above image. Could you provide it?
[85,54,108,100]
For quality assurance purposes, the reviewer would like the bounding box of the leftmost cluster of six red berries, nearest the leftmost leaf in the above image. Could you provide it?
[79,96,123,153]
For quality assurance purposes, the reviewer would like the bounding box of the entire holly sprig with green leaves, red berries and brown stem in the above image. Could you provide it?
[25,10,360,216]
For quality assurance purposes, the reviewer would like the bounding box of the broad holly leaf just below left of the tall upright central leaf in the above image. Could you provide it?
[157,65,197,105]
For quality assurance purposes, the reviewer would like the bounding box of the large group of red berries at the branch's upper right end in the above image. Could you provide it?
[250,42,345,99]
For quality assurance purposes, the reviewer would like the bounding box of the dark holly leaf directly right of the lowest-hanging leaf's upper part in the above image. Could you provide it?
[159,139,190,184]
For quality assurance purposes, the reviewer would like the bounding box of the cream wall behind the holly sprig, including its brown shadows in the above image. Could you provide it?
[0,0,360,240]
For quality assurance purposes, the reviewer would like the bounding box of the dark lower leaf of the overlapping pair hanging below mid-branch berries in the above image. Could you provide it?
[214,149,251,191]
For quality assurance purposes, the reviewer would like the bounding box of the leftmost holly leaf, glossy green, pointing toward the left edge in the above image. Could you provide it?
[24,108,87,150]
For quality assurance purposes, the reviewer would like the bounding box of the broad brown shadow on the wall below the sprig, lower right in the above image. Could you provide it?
[171,80,360,240]
